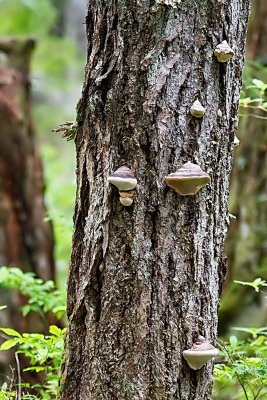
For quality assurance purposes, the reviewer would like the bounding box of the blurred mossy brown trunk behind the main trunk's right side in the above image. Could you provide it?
[219,0,267,334]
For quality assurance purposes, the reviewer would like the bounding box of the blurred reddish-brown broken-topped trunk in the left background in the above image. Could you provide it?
[0,38,55,380]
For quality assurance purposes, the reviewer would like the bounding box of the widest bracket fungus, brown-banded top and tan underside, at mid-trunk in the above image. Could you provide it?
[165,162,210,196]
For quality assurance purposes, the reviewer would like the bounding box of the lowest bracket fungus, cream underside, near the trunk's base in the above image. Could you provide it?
[183,335,218,370]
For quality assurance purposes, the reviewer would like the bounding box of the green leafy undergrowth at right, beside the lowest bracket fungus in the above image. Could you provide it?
[216,278,267,400]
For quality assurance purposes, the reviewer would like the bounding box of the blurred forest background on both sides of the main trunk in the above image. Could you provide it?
[0,0,267,400]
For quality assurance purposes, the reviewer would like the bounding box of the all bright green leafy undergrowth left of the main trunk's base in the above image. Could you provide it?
[0,267,66,400]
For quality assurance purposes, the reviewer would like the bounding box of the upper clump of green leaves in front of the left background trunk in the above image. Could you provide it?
[0,267,66,319]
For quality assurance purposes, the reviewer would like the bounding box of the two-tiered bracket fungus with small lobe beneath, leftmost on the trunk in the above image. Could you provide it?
[108,166,137,207]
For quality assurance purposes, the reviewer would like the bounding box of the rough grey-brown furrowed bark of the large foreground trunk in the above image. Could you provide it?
[59,0,249,400]
